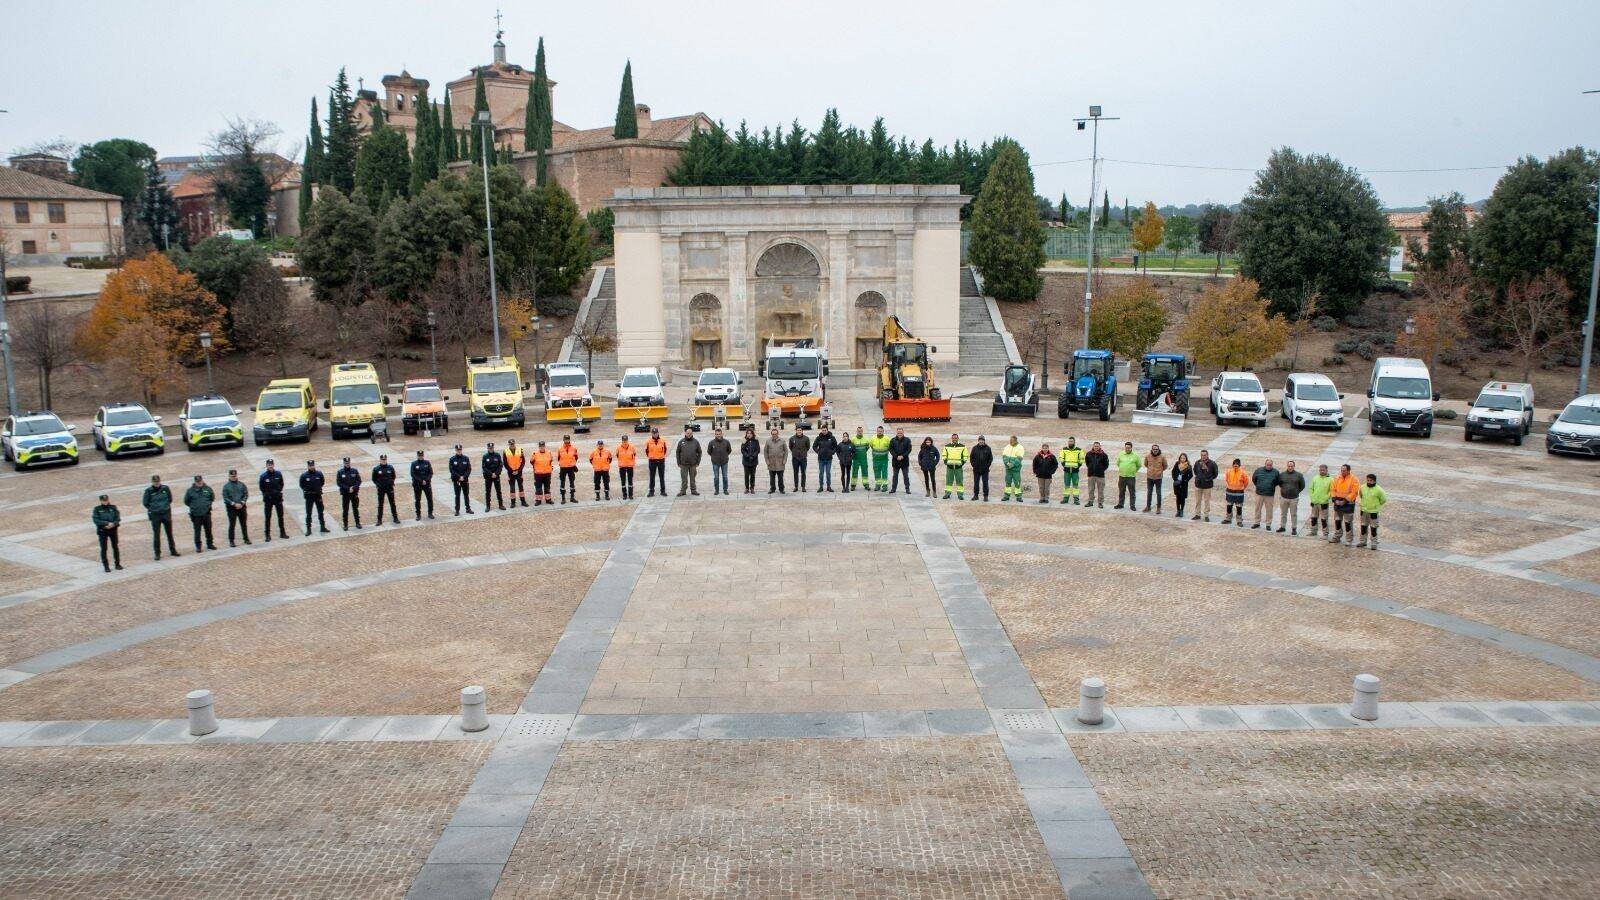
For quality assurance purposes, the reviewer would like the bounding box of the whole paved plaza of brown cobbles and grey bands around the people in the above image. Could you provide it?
[0,391,1600,900]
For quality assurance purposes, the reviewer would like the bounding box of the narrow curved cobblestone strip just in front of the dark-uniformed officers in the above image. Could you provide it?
[0,500,632,666]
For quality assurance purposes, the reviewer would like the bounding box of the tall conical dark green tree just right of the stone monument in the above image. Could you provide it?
[966,138,1045,301]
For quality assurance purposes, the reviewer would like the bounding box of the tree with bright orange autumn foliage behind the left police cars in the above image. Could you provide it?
[78,246,229,402]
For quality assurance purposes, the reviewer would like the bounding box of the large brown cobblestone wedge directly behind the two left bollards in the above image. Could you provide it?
[0,554,603,719]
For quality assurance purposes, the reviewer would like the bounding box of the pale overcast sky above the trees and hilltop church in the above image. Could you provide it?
[0,0,1600,207]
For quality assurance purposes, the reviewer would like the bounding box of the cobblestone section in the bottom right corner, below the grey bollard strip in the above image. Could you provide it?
[1070,729,1600,898]
